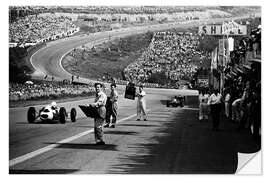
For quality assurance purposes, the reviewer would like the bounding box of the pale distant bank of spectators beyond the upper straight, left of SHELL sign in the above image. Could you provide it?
[78,8,231,26]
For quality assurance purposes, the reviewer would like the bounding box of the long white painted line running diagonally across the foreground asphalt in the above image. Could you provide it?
[9,109,150,167]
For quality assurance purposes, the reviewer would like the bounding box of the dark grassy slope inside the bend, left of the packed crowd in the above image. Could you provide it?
[62,33,152,79]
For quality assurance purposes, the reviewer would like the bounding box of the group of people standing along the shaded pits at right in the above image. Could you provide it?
[199,82,260,137]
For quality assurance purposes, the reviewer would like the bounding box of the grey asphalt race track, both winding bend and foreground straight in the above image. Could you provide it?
[9,16,252,174]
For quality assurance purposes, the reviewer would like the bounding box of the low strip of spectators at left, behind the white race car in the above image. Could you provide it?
[9,82,95,101]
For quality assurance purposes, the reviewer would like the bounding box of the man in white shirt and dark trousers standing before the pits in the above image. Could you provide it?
[208,89,221,130]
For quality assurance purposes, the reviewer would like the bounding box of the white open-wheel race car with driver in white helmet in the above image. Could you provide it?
[27,105,77,124]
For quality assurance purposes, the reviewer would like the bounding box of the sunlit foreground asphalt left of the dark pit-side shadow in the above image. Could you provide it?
[9,93,202,174]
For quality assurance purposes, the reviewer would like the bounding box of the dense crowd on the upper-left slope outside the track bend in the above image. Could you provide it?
[9,13,76,45]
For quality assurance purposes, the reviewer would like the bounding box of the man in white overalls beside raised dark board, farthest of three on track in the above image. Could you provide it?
[136,85,146,121]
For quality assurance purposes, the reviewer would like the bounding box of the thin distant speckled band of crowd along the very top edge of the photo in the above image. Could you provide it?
[9,6,258,17]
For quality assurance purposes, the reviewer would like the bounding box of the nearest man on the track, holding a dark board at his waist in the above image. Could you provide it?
[90,83,107,145]
